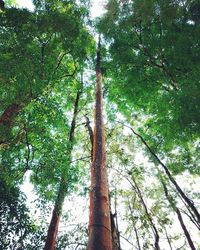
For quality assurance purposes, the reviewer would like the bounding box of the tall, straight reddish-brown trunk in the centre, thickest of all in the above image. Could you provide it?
[87,40,112,250]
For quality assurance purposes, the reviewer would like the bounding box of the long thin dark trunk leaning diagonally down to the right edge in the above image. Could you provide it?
[123,124,200,228]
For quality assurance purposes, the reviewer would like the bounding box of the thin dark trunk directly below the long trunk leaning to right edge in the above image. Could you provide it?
[161,177,196,250]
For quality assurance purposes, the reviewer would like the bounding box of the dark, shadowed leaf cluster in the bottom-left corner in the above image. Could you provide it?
[0,176,44,249]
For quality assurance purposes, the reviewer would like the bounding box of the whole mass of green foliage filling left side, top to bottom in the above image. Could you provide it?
[0,1,94,246]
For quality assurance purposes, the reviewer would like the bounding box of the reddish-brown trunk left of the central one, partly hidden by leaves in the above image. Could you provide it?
[44,90,81,250]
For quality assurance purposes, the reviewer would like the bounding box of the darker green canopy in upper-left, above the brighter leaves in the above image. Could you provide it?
[0,1,93,141]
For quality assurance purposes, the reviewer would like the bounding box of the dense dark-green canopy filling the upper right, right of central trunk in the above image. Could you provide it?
[97,0,200,148]
